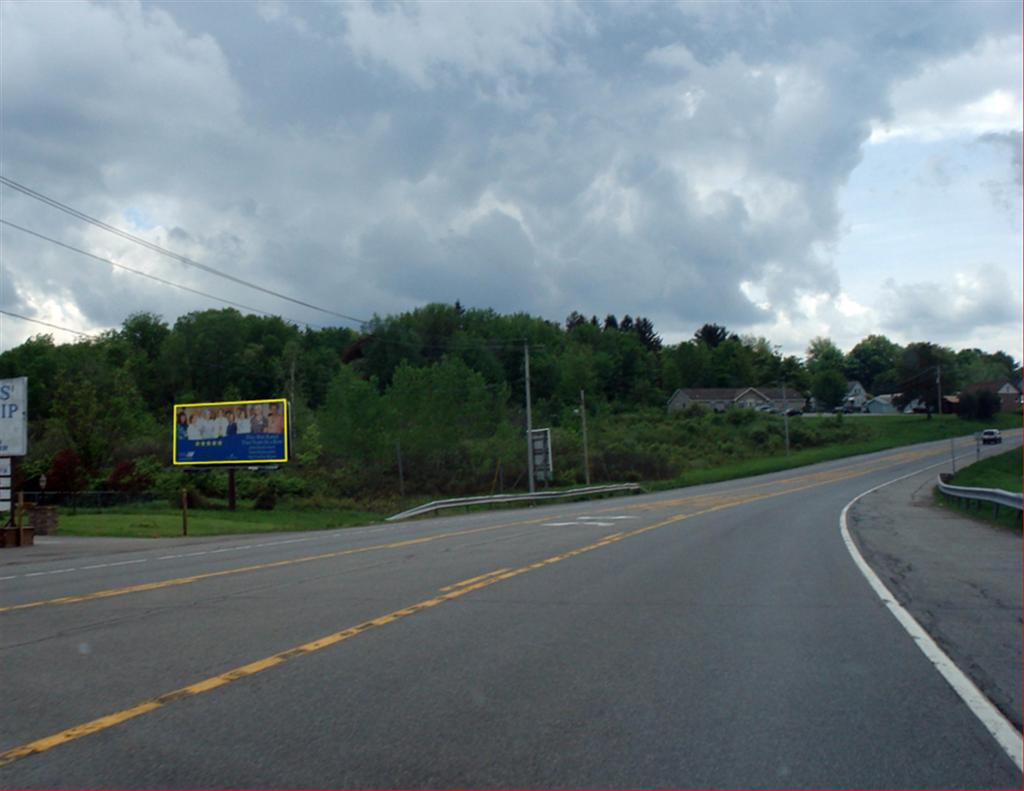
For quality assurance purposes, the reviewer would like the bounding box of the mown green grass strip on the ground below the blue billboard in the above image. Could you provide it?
[59,506,381,538]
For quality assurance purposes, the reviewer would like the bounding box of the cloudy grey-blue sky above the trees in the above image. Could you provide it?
[0,0,1022,359]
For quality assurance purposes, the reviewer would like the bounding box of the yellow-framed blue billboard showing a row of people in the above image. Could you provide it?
[173,399,289,465]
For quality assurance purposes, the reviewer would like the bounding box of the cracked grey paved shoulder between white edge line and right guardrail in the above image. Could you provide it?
[849,470,1024,730]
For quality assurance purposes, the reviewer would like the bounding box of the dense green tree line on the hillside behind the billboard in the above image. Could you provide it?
[0,302,1020,500]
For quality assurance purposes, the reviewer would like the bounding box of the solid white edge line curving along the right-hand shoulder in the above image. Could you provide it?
[839,460,1024,771]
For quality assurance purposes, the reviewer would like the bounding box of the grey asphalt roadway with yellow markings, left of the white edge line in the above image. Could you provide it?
[0,435,1022,788]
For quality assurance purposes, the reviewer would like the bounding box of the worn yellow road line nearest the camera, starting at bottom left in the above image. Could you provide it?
[0,450,921,766]
